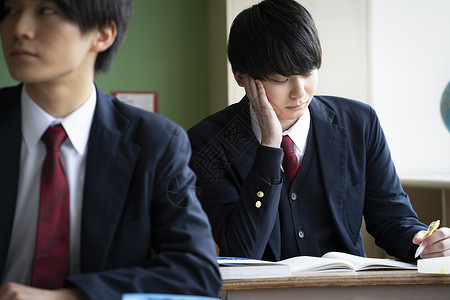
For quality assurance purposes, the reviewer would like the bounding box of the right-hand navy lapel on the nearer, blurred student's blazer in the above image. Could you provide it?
[81,89,140,272]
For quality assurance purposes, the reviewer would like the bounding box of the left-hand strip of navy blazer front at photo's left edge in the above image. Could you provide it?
[0,85,22,278]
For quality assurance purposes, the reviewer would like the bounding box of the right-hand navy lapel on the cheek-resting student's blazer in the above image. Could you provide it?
[309,98,352,244]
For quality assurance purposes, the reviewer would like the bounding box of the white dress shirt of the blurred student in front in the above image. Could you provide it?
[3,85,97,285]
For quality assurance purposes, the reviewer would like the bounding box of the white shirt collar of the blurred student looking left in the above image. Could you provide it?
[20,84,97,154]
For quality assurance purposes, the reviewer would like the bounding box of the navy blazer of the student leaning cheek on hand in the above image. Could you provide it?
[188,96,427,260]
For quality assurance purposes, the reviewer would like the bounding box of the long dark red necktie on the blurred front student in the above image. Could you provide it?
[31,125,70,289]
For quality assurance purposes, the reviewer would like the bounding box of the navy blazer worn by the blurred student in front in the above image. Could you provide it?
[0,85,221,299]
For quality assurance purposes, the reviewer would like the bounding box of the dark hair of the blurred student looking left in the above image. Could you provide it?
[0,0,133,73]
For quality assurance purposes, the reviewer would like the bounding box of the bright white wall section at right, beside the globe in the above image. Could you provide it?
[370,0,450,179]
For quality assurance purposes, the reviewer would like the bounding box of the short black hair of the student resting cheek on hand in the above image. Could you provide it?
[227,0,322,79]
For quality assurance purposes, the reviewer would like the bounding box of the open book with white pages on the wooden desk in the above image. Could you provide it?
[218,252,417,280]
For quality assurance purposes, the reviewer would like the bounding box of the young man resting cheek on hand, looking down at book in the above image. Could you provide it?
[188,0,450,261]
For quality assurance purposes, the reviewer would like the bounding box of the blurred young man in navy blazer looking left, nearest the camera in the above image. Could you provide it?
[0,0,221,300]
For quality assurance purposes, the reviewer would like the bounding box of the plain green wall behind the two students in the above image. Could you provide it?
[0,0,207,129]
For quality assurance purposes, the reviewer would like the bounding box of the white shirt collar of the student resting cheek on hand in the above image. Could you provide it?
[248,98,314,153]
